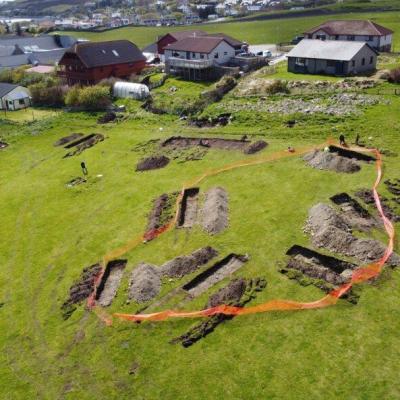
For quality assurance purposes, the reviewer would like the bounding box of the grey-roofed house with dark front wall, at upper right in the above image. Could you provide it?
[287,39,378,76]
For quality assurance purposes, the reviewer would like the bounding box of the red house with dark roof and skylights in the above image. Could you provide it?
[58,40,146,85]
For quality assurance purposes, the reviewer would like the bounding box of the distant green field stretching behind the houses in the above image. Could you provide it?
[65,11,400,51]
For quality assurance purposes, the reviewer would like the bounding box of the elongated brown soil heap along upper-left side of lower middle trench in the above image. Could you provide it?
[160,246,218,278]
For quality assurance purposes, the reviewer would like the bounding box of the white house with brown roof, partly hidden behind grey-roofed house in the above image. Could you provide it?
[304,20,393,52]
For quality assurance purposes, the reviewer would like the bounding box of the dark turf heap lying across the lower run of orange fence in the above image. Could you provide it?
[170,278,267,347]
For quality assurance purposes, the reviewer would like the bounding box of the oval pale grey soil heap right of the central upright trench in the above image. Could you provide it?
[201,187,229,235]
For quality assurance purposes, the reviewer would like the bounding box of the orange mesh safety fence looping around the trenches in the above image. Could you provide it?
[88,141,395,325]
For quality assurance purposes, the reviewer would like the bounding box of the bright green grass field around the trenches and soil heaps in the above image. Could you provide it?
[0,67,400,400]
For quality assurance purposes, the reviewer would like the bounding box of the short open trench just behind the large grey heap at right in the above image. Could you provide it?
[330,193,378,230]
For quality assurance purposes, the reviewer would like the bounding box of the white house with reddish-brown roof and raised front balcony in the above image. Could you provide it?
[164,36,236,80]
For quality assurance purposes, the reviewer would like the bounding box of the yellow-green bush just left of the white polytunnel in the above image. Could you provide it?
[65,85,111,111]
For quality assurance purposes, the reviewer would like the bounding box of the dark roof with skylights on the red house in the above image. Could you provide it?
[60,40,146,68]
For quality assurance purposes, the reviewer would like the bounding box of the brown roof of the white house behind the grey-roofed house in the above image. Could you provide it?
[305,20,393,36]
